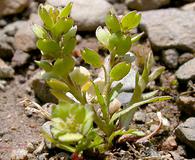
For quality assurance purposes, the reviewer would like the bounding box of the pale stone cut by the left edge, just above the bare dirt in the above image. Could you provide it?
[0,59,14,78]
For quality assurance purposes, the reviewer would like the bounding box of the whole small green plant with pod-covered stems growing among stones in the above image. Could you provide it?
[33,3,170,157]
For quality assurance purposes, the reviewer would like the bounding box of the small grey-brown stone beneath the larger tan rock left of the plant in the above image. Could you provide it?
[12,50,30,67]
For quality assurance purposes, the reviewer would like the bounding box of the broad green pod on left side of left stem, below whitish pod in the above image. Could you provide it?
[37,39,60,58]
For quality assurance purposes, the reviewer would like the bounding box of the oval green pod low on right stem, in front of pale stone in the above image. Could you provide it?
[110,62,131,81]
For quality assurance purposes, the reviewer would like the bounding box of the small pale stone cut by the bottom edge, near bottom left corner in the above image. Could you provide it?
[11,149,28,160]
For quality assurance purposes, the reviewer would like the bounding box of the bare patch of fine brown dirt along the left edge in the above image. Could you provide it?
[0,75,41,160]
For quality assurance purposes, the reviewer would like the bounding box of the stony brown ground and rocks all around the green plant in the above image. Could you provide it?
[0,0,195,160]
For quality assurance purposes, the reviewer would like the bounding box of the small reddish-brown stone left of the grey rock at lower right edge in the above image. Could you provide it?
[162,136,177,151]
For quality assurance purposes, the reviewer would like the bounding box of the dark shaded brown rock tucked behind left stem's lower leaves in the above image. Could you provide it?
[31,73,57,103]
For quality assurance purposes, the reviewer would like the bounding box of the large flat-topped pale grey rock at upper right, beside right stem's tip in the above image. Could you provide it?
[141,9,195,52]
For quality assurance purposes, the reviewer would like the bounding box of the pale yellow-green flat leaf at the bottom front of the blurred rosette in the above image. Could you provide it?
[58,133,83,143]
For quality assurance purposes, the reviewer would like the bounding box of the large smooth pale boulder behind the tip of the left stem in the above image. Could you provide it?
[46,0,112,31]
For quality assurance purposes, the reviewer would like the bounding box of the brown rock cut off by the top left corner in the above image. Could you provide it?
[0,0,30,17]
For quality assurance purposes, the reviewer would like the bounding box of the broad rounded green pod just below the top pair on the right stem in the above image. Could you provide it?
[109,33,131,56]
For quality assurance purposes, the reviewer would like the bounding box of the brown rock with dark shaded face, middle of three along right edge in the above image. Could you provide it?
[177,96,195,116]
